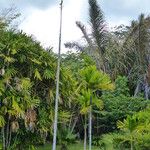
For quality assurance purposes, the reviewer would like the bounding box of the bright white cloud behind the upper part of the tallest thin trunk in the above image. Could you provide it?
[20,0,86,52]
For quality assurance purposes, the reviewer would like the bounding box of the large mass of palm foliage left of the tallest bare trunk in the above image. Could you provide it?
[0,18,59,149]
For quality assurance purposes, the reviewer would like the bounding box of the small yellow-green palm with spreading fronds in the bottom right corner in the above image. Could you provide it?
[117,108,150,150]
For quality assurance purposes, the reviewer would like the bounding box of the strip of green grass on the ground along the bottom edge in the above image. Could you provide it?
[36,143,100,150]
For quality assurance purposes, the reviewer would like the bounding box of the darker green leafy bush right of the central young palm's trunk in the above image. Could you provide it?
[95,77,149,134]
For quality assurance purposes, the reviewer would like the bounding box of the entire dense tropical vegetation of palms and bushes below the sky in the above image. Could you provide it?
[0,0,150,150]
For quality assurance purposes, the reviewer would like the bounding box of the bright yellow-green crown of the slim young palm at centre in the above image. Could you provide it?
[79,66,113,114]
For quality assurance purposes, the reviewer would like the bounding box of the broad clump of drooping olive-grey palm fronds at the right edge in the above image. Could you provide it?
[99,14,150,96]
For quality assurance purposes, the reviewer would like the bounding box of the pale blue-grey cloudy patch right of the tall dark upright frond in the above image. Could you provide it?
[101,0,150,26]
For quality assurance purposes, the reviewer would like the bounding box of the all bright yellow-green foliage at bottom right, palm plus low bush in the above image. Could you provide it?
[100,108,150,150]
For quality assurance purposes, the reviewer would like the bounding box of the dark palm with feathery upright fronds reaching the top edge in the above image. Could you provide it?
[65,0,107,71]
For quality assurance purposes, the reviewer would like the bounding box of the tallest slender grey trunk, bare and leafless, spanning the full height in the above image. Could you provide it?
[52,0,63,150]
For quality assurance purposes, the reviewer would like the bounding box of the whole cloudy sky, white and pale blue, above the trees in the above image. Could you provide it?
[0,0,150,53]
